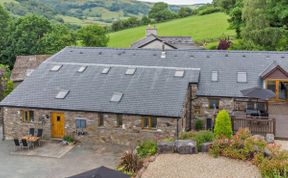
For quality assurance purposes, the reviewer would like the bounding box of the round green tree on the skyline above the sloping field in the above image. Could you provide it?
[149,2,176,22]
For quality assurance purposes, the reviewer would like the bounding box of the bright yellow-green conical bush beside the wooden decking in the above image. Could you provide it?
[214,110,233,138]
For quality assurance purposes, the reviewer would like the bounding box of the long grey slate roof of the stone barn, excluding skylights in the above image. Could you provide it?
[1,47,288,117]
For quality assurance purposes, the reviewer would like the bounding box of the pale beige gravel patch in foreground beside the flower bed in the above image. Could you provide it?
[142,153,261,178]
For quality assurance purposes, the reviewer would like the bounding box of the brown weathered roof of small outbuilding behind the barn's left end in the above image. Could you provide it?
[11,55,50,82]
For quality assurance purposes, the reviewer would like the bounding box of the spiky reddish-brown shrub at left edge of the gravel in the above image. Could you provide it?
[117,150,143,176]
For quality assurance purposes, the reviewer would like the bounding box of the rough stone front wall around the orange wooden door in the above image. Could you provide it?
[3,107,182,145]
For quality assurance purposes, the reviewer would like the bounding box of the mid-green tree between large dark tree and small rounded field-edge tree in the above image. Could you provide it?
[40,24,76,54]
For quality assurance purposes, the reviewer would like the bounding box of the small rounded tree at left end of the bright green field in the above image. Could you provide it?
[78,24,109,47]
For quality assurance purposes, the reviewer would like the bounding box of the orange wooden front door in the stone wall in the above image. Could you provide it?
[51,113,64,138]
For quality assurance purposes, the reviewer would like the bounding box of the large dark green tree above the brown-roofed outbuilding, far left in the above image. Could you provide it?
[0,14,51,67]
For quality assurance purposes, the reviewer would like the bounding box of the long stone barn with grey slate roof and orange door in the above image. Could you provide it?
[1,47,288,144]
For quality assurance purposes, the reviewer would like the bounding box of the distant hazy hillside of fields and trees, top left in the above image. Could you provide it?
[0,0,152,25]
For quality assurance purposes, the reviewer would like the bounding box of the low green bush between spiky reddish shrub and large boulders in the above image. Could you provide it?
[136,140,157,158]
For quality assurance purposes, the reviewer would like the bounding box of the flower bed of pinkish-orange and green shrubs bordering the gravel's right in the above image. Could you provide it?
[209,129,288,178]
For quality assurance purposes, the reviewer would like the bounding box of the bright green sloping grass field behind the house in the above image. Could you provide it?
[108,13,235,48]
